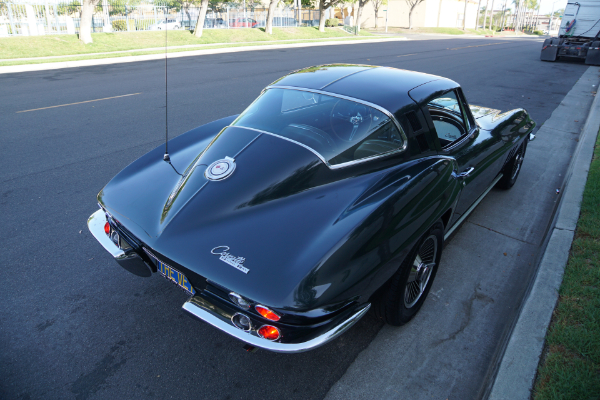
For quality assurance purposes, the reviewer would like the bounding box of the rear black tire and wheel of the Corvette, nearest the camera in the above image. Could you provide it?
[374,222,444,326]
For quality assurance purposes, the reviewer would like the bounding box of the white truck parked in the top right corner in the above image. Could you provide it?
[540,0,600,65]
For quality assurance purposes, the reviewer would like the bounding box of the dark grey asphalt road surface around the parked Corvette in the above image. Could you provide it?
[0,38,587,399]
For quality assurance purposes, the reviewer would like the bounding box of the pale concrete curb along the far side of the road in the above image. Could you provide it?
[0,37,407,74]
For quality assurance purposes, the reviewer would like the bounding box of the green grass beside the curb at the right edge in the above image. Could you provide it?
[533,130,600,400]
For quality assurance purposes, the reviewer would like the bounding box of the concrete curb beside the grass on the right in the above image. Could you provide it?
[488,67,600,400]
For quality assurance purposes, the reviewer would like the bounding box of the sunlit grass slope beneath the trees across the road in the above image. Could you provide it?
[0,27,371,61]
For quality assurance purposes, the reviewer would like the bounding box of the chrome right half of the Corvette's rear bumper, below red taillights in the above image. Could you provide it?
[182,297,371,353]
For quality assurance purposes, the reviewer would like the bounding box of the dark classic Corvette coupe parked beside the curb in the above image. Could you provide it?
[88,65,535,352]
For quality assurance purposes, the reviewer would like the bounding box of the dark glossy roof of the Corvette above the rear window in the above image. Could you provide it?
[271,64,459,114]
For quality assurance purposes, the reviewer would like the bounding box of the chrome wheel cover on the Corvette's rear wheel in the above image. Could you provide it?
[404,235,437,308]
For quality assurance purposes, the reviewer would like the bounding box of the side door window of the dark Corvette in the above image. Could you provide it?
[427,90,470,148]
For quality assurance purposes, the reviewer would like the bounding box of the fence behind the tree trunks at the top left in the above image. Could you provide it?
[0,0,319,37]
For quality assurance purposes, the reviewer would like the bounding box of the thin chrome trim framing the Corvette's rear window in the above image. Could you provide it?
[237,85,408,169]
